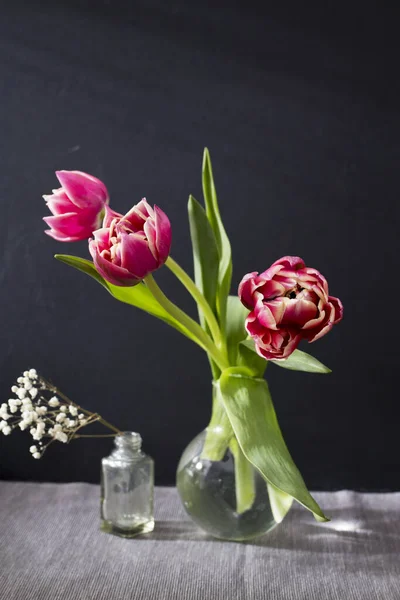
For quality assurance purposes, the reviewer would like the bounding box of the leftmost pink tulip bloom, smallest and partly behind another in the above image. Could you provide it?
[43,171,108,242]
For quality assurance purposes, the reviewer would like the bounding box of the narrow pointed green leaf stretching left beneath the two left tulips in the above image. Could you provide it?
[55,254,198,340]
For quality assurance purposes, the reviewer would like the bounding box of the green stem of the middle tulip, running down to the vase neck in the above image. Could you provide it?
[144,274,229,371]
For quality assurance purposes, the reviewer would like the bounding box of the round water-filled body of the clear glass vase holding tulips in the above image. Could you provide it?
[177,430,277,541]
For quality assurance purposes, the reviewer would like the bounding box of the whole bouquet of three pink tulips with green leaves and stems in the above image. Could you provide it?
[44,149,343,521]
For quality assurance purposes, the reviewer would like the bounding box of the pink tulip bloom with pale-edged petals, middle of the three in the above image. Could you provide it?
[89,199,171,286]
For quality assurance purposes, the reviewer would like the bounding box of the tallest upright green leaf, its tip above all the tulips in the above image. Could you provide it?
[202,148,232,331]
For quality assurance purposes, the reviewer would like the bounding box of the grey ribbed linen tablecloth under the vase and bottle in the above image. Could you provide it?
[0,482,400,600]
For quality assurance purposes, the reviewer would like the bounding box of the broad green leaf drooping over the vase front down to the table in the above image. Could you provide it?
[219,368,328,521]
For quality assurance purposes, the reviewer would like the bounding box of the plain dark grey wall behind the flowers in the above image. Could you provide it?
[0,0,400,490]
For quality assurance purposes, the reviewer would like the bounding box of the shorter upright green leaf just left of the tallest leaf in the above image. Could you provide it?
[188,196,219,329]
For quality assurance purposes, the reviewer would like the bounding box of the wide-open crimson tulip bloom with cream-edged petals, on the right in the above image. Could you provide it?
[239,256,343,360]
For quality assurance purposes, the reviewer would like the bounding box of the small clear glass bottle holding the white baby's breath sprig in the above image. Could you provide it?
[101,431,154,537]
